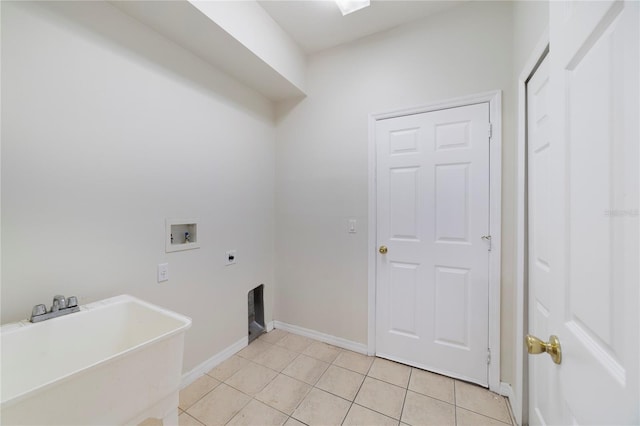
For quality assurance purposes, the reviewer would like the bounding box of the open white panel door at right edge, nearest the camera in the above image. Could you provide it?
[529,1,640,425]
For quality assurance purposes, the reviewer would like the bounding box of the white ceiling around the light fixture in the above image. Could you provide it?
[258,0,461,54]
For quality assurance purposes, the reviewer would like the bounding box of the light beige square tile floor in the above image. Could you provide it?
[170,330,512,426]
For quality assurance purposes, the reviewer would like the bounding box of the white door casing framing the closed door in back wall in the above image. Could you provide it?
[367,90,502,393]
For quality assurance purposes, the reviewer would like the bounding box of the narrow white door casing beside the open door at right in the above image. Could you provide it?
[511,27,549,424]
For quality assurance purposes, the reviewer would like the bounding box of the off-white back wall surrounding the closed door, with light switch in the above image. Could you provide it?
[274,2,516,382]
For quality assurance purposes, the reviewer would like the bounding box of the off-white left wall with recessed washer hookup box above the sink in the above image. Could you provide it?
[1,2,275,371]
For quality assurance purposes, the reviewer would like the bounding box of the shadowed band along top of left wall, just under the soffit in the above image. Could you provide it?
[18,2,274,122]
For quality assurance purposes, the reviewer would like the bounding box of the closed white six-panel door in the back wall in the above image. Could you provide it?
[376,103,491,386]
